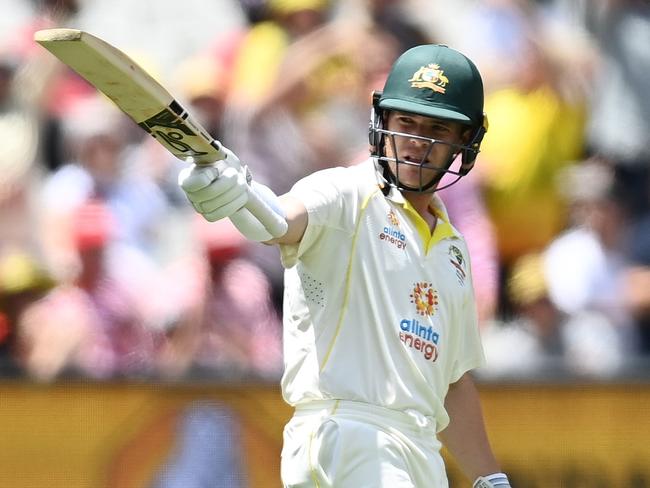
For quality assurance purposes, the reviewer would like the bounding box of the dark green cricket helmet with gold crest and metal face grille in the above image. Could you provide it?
[369,44,487,192]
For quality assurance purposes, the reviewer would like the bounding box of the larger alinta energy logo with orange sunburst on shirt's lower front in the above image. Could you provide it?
[399,282,440,362]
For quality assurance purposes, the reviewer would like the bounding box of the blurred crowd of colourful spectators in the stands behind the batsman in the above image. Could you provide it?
[0,0,650,381]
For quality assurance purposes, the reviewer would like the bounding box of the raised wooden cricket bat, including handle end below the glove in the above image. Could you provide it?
[34,28,287,237]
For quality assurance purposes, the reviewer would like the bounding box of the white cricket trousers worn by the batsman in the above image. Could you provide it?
[281,400,449,488]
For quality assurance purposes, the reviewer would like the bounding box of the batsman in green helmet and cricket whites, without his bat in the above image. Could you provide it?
[179,45,510,488]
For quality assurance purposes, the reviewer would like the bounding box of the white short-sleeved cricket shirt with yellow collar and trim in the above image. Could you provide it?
[280,160,484,431]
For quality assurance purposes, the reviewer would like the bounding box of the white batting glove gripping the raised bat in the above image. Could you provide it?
[178,148,250,222]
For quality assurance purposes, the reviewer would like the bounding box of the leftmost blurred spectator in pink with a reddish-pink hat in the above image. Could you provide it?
[19,202,156,380]
